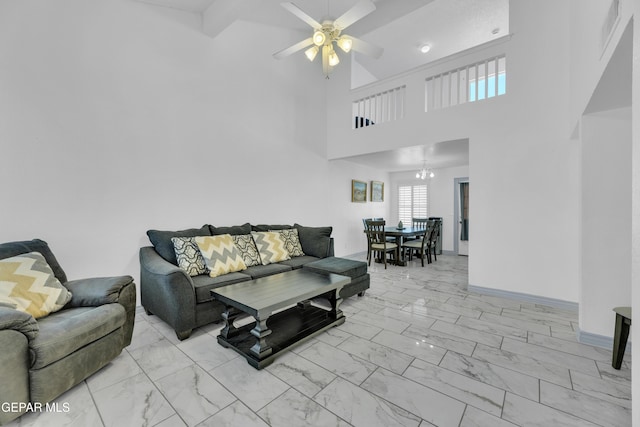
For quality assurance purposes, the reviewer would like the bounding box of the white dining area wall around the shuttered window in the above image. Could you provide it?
[389,166,473,251]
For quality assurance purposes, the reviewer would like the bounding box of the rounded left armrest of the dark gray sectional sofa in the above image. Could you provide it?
[140,246,196,335]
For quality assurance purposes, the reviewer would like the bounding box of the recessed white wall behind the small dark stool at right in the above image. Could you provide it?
[580,108,631,336]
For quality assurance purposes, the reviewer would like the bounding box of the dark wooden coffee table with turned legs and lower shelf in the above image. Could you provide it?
[211,269,351,369]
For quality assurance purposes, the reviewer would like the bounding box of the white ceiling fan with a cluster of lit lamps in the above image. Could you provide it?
[273,0,383,78]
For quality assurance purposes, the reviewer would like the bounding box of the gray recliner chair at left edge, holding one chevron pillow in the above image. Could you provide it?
[0,240,136,425]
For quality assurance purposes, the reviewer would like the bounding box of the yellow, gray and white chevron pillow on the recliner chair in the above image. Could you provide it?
[0,252,72,319]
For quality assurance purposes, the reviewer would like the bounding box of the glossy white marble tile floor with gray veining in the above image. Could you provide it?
[11,255,631,427]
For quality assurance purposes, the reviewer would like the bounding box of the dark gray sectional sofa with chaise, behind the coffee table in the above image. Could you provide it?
[140,223,369,340]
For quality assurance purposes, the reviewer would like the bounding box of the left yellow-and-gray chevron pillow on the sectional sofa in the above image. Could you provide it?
[195,234,247,277]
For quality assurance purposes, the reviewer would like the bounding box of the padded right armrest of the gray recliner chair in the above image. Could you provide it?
[64,276,136,347]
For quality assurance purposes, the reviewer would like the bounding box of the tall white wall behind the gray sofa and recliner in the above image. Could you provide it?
[0,0,362,290]
